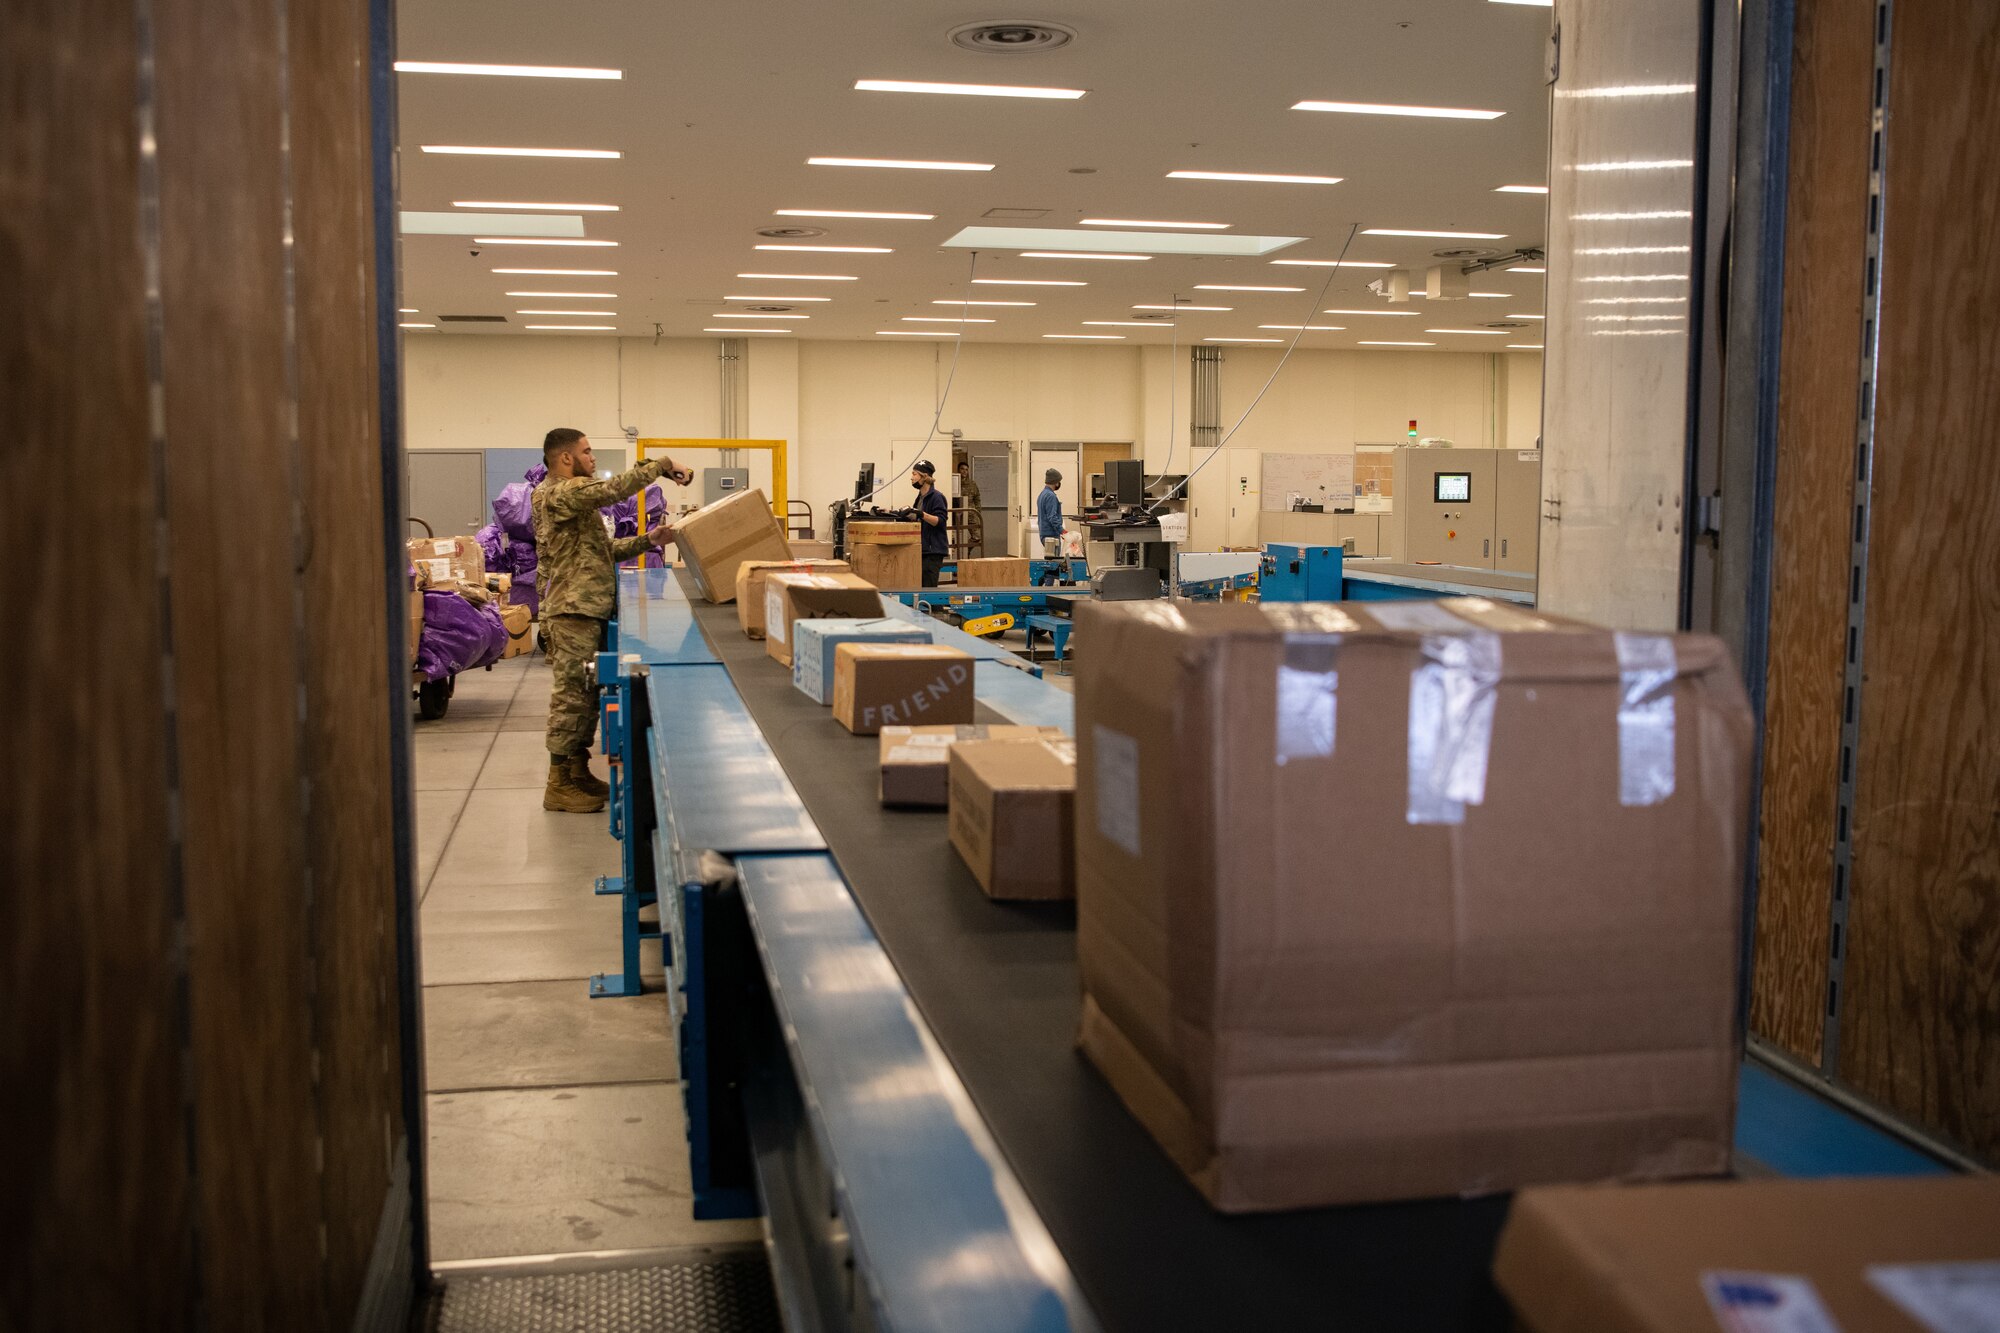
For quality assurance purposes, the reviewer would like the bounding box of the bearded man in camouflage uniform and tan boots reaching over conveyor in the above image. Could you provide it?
[528,428,694,815]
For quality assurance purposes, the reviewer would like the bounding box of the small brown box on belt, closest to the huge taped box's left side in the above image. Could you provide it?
[950,739,1076,899]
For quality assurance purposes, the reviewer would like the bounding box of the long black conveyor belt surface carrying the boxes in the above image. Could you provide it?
[690,572,1508,1333]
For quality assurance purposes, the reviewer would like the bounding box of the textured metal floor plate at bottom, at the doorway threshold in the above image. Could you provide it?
[438,1255,784,1333]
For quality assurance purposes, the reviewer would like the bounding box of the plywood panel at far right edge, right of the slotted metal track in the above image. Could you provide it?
[1840,0,2000,1161]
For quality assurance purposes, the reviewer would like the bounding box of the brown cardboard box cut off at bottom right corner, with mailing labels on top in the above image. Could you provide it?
[1494,1177,2000,1333]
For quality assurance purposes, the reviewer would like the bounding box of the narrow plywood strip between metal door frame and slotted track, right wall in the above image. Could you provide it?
[1750,4,1874,1065]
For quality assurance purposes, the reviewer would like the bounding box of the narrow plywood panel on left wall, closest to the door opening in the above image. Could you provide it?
[290,0,402,1311]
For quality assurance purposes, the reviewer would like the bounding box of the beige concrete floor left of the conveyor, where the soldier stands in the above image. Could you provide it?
[416,654,762,1263]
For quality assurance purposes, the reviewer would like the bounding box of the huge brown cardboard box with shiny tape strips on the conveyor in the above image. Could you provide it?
[1076,598,1750,1211]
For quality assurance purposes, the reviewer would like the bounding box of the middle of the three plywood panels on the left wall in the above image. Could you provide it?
[154,0,322,1329]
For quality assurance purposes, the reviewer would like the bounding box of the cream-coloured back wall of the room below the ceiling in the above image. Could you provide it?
[404,334,1542,526]
